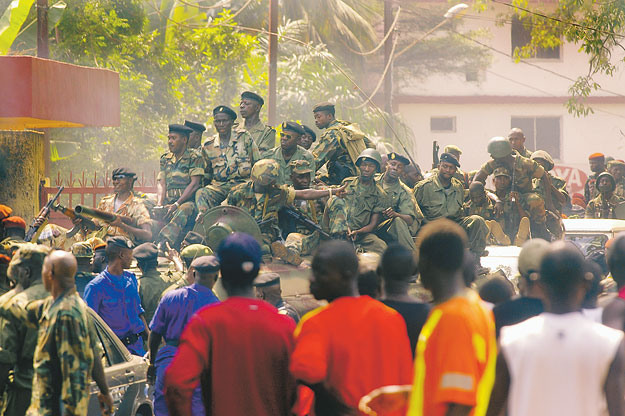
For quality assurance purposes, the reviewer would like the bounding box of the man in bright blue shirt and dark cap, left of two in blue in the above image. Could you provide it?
[84,236,148,356]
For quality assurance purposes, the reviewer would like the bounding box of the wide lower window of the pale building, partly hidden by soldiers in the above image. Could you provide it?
[510,117,561,159]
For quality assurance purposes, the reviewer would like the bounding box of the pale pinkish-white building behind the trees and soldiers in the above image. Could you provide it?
[394,3,625,193]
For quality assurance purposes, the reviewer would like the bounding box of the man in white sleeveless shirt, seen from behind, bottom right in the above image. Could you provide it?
[487,241,625,416]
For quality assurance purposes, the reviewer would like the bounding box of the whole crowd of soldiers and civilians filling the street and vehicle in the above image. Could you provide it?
[0,91,625,416]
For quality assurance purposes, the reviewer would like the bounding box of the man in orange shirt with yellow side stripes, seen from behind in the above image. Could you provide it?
[408,219,497,416]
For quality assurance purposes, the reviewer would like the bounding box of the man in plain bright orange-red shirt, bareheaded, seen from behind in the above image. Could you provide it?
[290,241,412,415]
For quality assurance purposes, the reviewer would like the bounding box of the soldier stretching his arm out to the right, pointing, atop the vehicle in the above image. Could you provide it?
[228,159,344,265]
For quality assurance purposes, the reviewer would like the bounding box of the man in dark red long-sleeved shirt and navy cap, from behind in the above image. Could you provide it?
[165,233,295,416]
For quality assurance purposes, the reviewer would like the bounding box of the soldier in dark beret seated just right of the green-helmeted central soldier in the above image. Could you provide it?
[376,152,423,251]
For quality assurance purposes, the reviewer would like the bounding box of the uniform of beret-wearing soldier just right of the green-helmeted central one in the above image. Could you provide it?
[376,173,423,250]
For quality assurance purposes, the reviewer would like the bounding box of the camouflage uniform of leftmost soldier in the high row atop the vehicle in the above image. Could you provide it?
[157,149,205,244]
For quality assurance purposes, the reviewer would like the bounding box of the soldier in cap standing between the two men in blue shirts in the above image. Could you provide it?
[132,243,171,322]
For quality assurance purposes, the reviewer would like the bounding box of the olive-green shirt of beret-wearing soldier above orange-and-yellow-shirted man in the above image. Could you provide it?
[414,175,464,222]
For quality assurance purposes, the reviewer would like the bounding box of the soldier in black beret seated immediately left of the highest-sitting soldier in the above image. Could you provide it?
[195,105,260,214]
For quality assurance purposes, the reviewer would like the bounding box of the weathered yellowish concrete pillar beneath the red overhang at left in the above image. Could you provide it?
[0,130,44,224]
